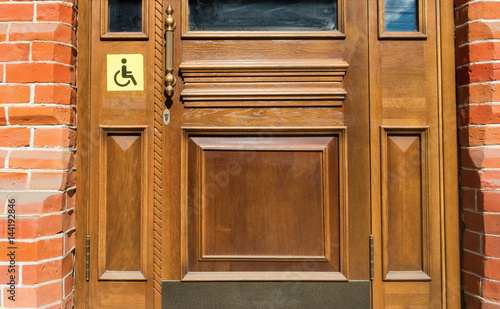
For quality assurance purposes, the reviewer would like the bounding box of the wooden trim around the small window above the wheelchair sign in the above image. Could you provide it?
[100,0,148,40]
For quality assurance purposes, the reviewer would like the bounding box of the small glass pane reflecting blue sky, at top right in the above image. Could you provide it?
[384,0,418,31]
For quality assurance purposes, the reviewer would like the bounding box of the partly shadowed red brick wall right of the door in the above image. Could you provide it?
[455,0,500,308]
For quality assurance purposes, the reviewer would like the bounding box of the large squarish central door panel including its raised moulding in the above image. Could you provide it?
[182,128,345,280]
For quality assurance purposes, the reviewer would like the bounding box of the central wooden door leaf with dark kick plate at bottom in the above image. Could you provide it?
[161,1,370,308]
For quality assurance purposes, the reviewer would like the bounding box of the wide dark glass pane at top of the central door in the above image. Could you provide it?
[189,0,337,31]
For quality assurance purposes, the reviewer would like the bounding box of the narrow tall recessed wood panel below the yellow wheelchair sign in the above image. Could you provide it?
[99,128,146,280]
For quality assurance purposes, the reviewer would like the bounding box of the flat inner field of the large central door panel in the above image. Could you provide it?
[201,150,325,260]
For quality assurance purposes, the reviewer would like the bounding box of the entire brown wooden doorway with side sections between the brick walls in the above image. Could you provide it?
[77,0,458,308]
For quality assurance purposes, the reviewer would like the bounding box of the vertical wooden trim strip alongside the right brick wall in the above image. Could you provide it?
[442,0,461,308]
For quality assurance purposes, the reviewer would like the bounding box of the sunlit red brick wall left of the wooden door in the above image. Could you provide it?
[0,0,76,308]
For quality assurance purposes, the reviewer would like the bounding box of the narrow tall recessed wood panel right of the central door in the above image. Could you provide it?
[382,128,430,280]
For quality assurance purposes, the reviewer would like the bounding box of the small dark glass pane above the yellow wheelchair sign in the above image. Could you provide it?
[108,0,142,32]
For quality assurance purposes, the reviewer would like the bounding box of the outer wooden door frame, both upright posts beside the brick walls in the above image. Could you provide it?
[74,0,460,308]
